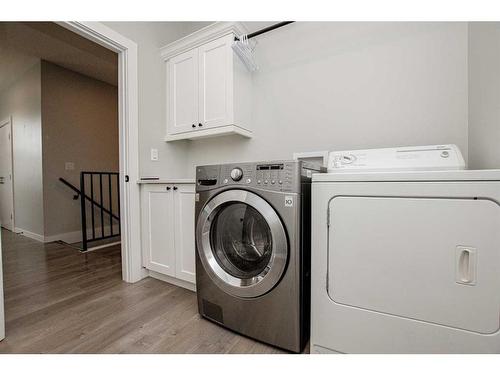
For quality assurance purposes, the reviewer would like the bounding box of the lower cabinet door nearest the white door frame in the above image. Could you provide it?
[141,185,175,277]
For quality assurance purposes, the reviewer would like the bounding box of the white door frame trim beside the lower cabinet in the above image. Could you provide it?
[57,21,148,283]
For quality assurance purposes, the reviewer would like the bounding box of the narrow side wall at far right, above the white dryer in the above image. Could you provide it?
[469,22,500,168]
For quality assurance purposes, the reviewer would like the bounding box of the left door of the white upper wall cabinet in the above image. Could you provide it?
[167,49,198,134]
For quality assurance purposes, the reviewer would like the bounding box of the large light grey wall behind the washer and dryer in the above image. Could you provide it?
[181,22,468,176]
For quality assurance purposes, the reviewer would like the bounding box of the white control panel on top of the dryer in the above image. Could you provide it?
[328,145,465,172]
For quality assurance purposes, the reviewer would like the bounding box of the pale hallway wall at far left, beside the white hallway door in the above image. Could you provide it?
[0,62,43,236]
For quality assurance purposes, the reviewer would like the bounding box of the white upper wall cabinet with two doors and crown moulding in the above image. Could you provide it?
[161,22,252,141]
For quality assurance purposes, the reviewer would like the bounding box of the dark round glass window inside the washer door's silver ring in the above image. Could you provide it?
[210,203,272,278]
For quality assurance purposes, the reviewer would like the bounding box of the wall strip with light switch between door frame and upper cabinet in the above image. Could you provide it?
[104,22,209,177]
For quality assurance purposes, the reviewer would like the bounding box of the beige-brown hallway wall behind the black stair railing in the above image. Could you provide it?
[41,62,119,236]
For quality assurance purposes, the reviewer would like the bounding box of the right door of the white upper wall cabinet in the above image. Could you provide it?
[198,35,234,129]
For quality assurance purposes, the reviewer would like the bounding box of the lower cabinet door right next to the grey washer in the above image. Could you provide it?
[174,184,196,283]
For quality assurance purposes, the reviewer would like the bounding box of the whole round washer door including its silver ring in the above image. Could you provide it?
[196,189,288,298]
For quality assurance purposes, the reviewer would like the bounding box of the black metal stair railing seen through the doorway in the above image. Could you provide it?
[59,171,121,251]
